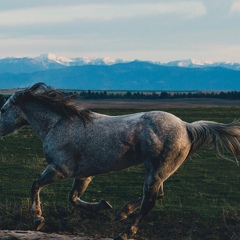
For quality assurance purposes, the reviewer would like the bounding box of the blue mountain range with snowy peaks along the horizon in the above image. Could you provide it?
[0,54,240,91]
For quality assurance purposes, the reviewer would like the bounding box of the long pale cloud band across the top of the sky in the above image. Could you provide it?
[0,1,206,26]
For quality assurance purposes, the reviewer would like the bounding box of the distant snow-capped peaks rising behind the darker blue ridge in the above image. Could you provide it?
[0,53,240,74]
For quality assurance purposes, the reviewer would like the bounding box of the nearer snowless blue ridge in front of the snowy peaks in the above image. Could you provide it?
[0,61,240,91]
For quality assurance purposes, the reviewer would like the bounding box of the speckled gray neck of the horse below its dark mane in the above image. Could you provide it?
[25,103,61,141]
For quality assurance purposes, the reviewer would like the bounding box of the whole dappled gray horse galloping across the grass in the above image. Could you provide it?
[0,83,240,239]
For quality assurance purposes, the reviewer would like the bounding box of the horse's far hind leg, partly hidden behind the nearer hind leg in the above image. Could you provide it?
[114,184,164,221]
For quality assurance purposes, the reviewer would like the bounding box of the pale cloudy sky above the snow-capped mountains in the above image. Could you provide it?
[0,0,240,63]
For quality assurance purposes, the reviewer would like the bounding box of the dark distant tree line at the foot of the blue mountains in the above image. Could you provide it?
[68,90,240,100]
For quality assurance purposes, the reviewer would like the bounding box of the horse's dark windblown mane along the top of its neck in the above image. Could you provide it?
[21,83,93,124]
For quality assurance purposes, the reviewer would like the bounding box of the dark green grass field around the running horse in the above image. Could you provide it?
[0,107,240,240]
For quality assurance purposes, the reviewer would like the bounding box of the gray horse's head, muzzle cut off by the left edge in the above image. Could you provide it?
[0,92,27,137]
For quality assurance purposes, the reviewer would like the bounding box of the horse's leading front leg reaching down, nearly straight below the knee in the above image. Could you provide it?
[31,164,65,230]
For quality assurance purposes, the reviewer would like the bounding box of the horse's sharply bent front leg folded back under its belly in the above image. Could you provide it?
[69,177,112,211]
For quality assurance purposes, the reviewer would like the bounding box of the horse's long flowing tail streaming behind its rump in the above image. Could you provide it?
[187,120,240,161]
